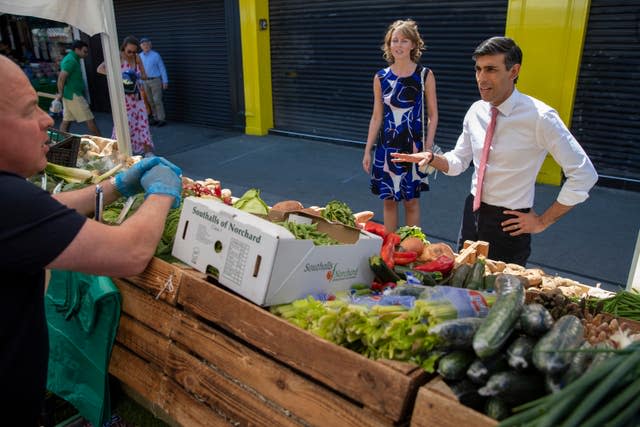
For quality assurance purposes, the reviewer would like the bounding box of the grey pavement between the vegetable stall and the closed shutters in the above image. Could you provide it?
[63,113,640,291]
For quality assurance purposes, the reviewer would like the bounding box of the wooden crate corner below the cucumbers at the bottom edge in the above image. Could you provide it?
[411,377,498,427]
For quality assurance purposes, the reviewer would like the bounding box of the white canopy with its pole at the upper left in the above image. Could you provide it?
[0,0,131,155]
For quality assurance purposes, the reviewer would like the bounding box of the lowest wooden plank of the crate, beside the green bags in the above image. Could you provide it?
[109,344,230,427]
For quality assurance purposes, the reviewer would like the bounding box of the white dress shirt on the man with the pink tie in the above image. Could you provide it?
[444,89,598,209]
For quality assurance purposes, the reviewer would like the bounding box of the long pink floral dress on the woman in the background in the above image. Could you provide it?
[111,61,154,154]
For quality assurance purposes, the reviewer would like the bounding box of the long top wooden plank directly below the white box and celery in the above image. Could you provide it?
[178,273,427,421]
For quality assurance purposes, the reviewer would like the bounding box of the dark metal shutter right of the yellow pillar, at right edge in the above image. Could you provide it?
[571,0,640,188]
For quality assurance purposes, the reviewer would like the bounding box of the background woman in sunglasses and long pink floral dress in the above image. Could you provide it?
[98,36,154,156]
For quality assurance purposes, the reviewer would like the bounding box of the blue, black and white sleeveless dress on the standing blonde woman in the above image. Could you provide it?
[371,65,429,201]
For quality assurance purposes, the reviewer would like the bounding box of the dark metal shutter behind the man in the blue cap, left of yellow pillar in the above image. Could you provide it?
[114,0,243,128]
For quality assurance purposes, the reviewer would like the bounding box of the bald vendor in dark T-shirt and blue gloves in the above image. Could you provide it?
[0,56,182,426]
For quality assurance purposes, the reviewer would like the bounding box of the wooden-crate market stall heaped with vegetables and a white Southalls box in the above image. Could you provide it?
[26,145,640,427]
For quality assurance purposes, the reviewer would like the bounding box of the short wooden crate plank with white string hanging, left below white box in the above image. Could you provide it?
[126,257,188,305]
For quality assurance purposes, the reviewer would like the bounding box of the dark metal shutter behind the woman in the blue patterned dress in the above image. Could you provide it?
[269,0,507,147]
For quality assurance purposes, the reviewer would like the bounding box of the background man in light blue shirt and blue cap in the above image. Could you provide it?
[140,37,169,126]
